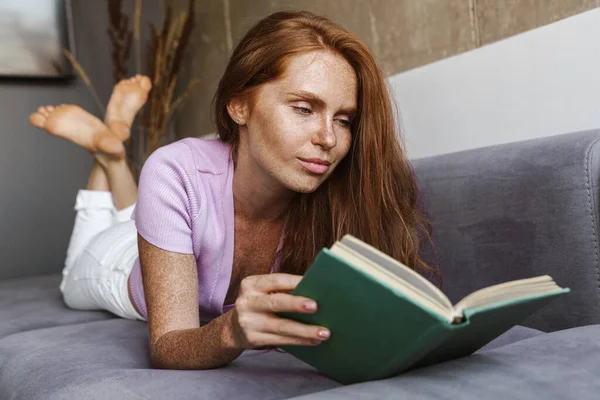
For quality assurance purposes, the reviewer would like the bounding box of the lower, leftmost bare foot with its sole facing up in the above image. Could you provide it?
[29,104,125,163]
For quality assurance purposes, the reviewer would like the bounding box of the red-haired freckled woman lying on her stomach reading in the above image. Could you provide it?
[32,12,437,369]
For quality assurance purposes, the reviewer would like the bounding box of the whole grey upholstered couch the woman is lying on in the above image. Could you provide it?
[0,131,600,400]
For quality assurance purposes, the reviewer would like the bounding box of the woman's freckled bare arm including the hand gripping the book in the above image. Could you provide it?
[138,234,329,369]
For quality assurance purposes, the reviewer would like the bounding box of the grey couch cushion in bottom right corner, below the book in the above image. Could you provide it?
[288,325,600,400]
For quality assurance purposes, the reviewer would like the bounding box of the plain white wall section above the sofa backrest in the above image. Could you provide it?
[389,9,600,159]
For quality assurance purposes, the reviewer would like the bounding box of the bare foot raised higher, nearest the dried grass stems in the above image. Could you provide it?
[104,75,152,142]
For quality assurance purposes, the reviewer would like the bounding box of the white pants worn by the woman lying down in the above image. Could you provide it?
[60,190,144,320]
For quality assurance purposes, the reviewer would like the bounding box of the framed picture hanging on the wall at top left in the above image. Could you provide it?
[0,0,75,79]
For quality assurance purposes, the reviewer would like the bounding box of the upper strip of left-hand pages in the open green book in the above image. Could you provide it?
[340,235,452,308]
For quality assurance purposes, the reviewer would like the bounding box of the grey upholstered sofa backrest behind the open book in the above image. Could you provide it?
[412,130,600,331]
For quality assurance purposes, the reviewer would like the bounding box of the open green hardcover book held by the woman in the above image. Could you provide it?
[279,235,569,384]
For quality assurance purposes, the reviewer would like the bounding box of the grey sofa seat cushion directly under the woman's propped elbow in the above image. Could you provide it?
[0,319,548,400]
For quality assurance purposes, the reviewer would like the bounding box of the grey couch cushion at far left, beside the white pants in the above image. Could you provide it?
[0,275,115,338]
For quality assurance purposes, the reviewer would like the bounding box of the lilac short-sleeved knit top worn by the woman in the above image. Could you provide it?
[129,138,281,323]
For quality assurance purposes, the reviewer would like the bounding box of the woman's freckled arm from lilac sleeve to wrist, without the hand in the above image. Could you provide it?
[138,234,244,369]
